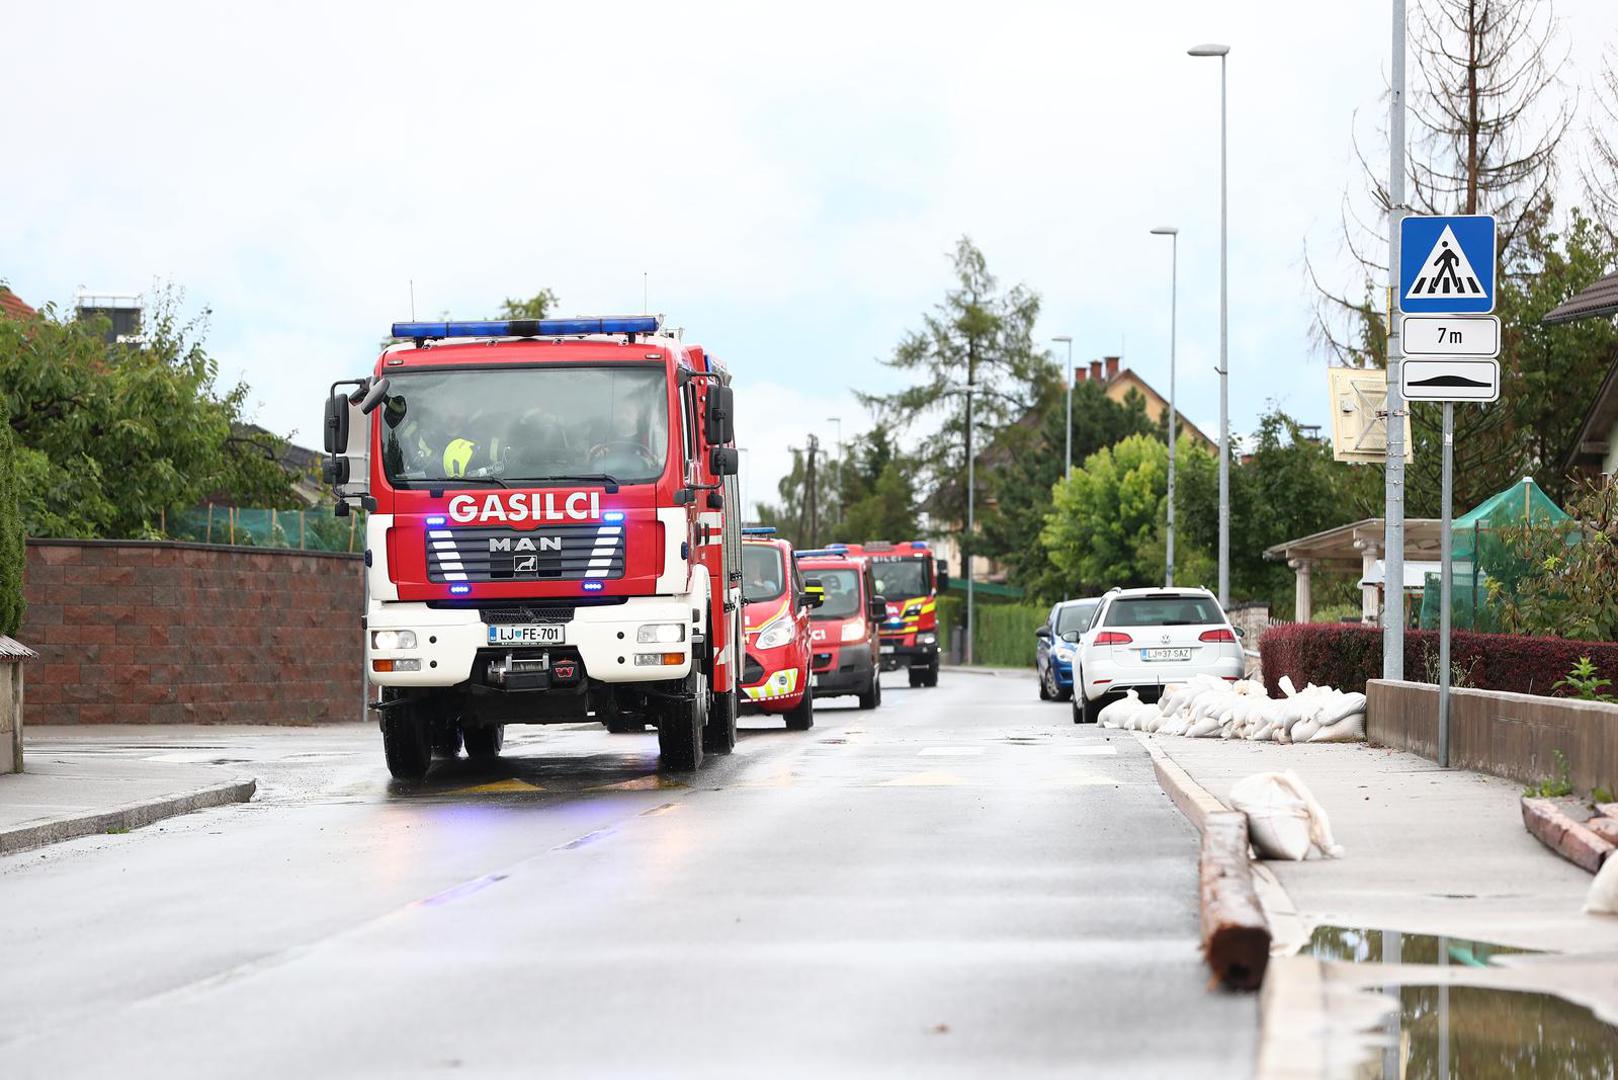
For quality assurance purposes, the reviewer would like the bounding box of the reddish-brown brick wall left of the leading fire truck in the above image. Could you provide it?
[18,541,364,724]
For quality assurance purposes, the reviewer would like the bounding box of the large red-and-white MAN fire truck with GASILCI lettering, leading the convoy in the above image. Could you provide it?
[325,316,741,779]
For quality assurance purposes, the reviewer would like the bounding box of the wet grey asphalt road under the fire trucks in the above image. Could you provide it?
[0,672,1257,1077]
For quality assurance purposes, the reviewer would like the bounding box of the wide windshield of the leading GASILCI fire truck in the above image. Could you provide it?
[379,364,668,487]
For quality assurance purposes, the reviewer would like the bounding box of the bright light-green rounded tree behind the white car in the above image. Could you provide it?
[1039,434,1215,596]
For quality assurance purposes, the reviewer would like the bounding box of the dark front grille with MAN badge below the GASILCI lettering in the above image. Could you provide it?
[427,523,623,581]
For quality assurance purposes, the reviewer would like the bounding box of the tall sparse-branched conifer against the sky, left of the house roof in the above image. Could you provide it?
[859,236,1057,540]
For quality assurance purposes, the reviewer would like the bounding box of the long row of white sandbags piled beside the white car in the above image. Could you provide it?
[1100,675,1366,743]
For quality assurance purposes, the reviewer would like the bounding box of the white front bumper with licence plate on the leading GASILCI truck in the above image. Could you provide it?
[366,596,705,688]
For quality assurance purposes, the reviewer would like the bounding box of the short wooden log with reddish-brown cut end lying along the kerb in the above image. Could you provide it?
[1199,811,1270,989]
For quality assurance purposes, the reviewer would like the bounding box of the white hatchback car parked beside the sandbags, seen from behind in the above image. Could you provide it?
[1073,588,1243,724]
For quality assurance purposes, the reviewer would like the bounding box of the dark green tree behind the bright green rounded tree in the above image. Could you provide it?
[979,381,1167,601]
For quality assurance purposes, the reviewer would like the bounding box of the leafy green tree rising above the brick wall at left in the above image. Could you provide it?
[0,291,298,538]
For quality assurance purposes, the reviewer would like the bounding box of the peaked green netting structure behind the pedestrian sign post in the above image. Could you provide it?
[1421,478,1579,633]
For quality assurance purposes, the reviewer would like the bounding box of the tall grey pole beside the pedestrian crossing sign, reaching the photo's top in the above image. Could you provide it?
[1382,0,1404,678]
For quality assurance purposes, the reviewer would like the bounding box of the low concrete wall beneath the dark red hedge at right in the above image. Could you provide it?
[1366,678,1618,793]
